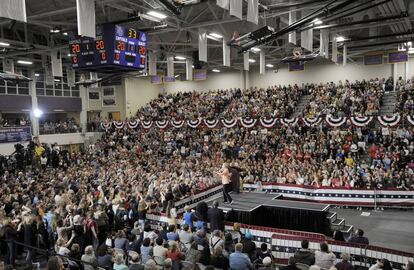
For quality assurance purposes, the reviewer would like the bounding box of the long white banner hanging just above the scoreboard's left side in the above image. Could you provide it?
[76,0,96,38]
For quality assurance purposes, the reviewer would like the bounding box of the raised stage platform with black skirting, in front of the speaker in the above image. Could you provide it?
[206,192,331,235]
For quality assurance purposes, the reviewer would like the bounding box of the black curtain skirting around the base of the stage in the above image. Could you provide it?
[227,205,331,235]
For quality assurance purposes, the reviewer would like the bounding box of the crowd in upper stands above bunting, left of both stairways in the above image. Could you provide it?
[136,85,304,120]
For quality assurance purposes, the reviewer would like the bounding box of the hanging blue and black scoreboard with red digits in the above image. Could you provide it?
[69,24,147,70]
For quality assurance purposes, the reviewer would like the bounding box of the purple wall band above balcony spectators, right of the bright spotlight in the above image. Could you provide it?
[37,97,82,112]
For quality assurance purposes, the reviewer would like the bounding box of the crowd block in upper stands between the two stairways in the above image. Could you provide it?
[304,79,384,117]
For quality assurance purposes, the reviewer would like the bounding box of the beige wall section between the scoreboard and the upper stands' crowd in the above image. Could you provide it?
[124,78,162,117]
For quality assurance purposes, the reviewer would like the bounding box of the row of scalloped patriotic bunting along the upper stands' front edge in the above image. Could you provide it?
[101,114,414,130]
